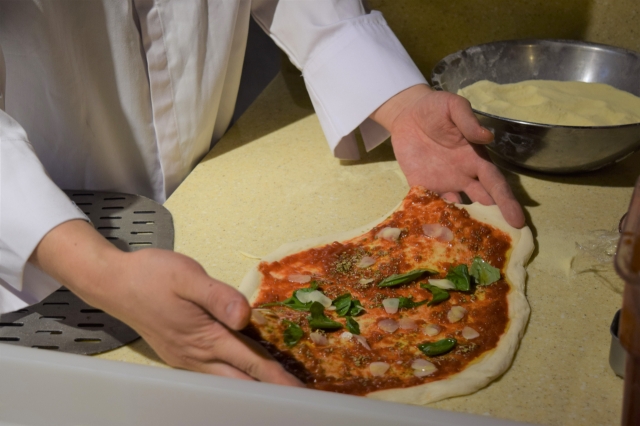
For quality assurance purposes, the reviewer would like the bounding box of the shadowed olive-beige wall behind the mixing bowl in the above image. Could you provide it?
[369,0,640,81]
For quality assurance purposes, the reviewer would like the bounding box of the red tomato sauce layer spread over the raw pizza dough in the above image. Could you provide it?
[246,188,511,395]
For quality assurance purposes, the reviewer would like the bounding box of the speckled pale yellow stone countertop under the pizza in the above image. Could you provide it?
[100,74,640,425]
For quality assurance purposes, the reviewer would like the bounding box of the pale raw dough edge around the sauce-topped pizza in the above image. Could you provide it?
[239,191,534,405]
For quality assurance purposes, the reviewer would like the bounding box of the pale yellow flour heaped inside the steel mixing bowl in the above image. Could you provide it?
[458,80,640,126]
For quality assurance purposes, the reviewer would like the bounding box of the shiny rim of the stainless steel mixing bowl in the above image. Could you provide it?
[431,38,640,130]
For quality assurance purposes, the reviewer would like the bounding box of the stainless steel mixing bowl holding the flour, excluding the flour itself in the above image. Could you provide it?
[431,40,640,173]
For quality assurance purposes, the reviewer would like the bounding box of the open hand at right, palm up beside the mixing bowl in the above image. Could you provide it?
[371,85,525,228]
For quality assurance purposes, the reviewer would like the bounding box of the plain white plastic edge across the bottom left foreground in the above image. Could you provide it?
[0,344,522,426]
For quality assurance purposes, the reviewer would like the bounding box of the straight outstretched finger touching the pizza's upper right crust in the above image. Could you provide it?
[478,163,525,228]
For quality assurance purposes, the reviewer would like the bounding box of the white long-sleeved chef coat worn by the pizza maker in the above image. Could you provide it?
[0,0,425,312]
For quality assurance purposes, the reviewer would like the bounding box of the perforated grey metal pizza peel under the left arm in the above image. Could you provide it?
[0,190,174,355]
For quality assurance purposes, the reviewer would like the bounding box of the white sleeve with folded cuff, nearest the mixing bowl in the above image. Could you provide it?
[252,0,427,160]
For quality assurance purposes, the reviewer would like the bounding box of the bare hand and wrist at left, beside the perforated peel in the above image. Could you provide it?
[30,220,301,386]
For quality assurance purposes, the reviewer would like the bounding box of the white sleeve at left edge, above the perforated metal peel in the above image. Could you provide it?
[0,110,87,313]
